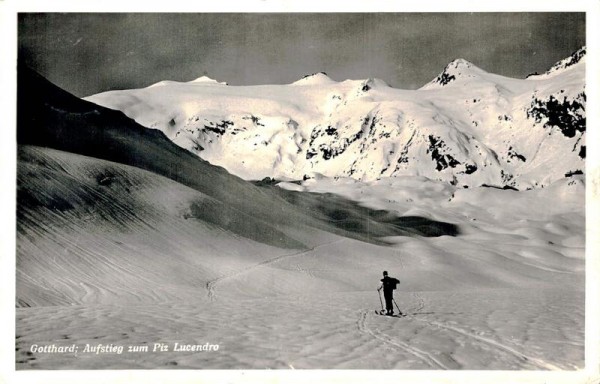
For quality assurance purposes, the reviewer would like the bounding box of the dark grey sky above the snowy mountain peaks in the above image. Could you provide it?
[18,13,585,97]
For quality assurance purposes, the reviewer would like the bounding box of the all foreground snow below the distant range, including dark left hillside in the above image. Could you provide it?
[16,68,585,370]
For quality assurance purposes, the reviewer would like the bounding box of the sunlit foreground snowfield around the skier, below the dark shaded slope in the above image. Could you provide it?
[17,148,585,370]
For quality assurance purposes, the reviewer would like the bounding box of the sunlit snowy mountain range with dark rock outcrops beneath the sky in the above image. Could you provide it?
[87,49,585,189]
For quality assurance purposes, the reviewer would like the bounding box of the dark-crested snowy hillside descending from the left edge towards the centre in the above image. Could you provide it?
[16,67,458,307]
